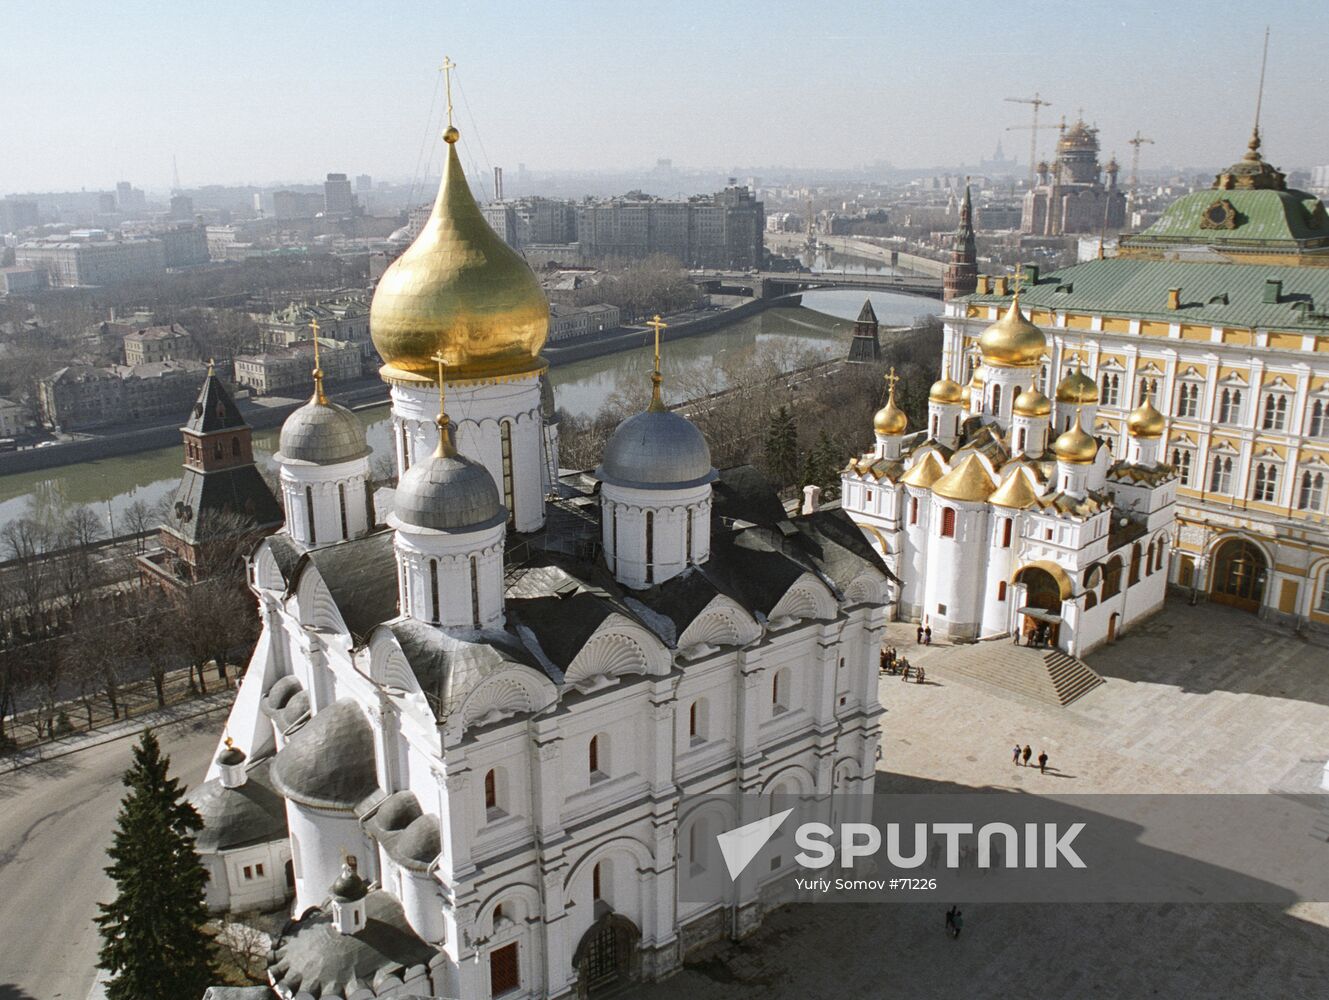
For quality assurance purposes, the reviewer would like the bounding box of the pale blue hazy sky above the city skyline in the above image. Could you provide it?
[0,0,1329,193]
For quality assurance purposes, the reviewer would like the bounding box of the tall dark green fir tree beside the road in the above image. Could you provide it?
[97,730,215,1000]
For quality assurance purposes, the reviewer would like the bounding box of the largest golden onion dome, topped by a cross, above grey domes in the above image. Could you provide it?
[369,126,549,382]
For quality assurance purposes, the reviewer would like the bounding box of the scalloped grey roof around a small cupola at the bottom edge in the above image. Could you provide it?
[268,890,444,997]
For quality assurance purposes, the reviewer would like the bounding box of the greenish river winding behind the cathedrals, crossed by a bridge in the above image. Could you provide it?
[0,283,941,533]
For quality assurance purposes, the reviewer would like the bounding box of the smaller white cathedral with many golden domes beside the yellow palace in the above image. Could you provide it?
[841,291,1176,656]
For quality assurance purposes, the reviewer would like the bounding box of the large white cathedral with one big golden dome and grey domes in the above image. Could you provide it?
[193,119,887,1000]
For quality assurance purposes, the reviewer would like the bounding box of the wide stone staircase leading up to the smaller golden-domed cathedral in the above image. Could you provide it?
[906,640,1106,705]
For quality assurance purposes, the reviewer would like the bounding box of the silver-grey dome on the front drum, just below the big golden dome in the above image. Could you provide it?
[395,452,508,532]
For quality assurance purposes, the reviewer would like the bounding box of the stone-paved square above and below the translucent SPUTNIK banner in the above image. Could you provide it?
[633,601,1329,1000]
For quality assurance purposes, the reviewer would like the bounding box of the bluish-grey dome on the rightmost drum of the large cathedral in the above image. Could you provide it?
[595,408,716,489]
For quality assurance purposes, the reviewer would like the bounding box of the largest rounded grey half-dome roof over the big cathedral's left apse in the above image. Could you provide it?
[272,698,377,810]
